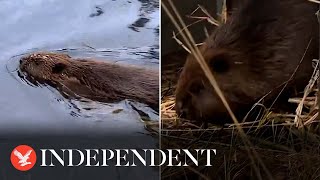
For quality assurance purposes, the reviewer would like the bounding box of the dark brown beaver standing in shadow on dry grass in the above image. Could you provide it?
[176,0,318,124]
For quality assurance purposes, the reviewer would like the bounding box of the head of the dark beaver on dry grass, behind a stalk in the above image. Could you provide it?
[176,45,260,124]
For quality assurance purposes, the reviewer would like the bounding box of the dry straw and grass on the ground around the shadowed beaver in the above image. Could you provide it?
[154,0,320,179]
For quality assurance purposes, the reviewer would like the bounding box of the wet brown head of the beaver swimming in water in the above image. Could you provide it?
[20,53,71,81]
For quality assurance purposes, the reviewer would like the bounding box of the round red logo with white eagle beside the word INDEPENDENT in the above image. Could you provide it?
[10,145,37,171]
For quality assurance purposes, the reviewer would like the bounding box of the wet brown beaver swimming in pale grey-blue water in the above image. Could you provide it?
[20,53,159,110]
